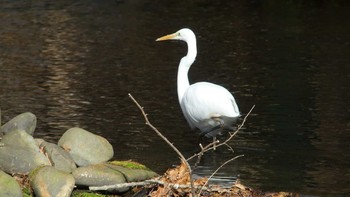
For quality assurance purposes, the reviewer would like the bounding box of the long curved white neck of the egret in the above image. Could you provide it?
[177,37,197,104]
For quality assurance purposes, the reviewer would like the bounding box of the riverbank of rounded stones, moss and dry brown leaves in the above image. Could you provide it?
[0,112,294,197]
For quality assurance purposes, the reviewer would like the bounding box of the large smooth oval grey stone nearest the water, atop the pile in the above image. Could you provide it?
[58,128,113,166]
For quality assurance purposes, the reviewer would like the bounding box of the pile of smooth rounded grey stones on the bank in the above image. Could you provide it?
[0,112,157,196]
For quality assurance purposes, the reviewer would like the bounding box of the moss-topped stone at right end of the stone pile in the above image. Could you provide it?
[105,161,158,182]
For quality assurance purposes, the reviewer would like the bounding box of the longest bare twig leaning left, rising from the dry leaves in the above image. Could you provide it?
[129,93,196,197]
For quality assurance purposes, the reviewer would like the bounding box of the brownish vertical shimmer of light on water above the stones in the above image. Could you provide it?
[39,7,90,134]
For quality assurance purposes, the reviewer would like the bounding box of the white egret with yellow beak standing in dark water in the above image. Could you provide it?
[156,28,240,140]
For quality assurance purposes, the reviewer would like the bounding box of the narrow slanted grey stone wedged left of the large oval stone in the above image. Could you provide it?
[36,141,77,173]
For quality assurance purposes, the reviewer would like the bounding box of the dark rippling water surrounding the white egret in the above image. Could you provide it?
[0,0,350,196]
